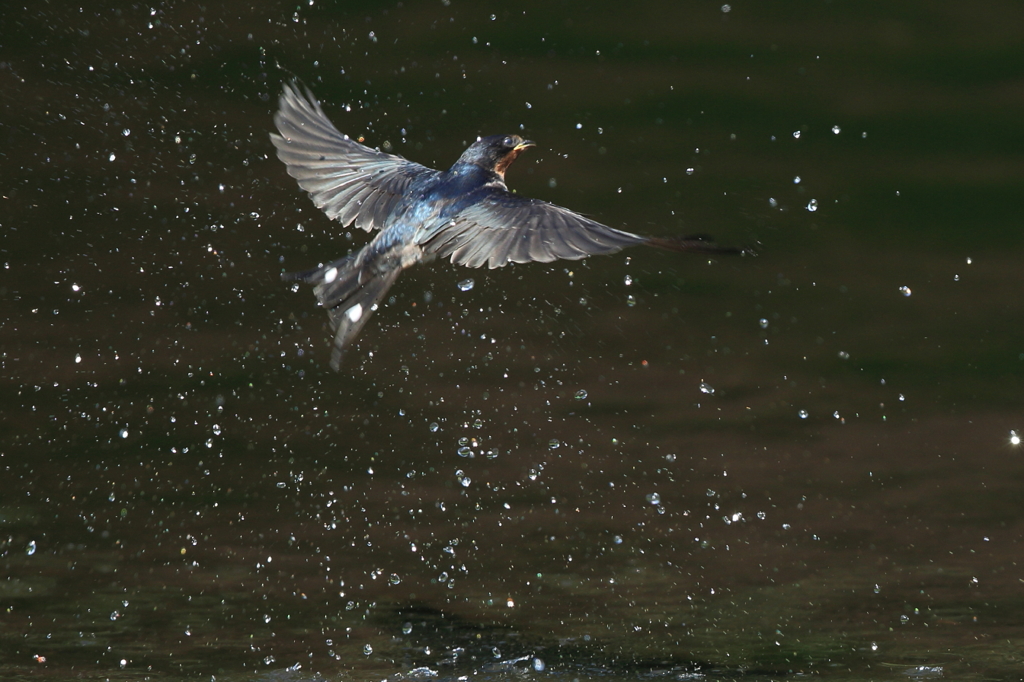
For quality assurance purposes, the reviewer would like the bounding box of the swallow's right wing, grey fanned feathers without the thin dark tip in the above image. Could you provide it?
[422,187,648,268]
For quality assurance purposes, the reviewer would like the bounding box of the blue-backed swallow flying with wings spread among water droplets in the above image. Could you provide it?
[270,82,744,370]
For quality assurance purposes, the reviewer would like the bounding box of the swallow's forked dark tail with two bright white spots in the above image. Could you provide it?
[283,254,401,370]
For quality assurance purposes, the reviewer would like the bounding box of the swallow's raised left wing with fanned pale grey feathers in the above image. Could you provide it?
[270,83,437,231]
